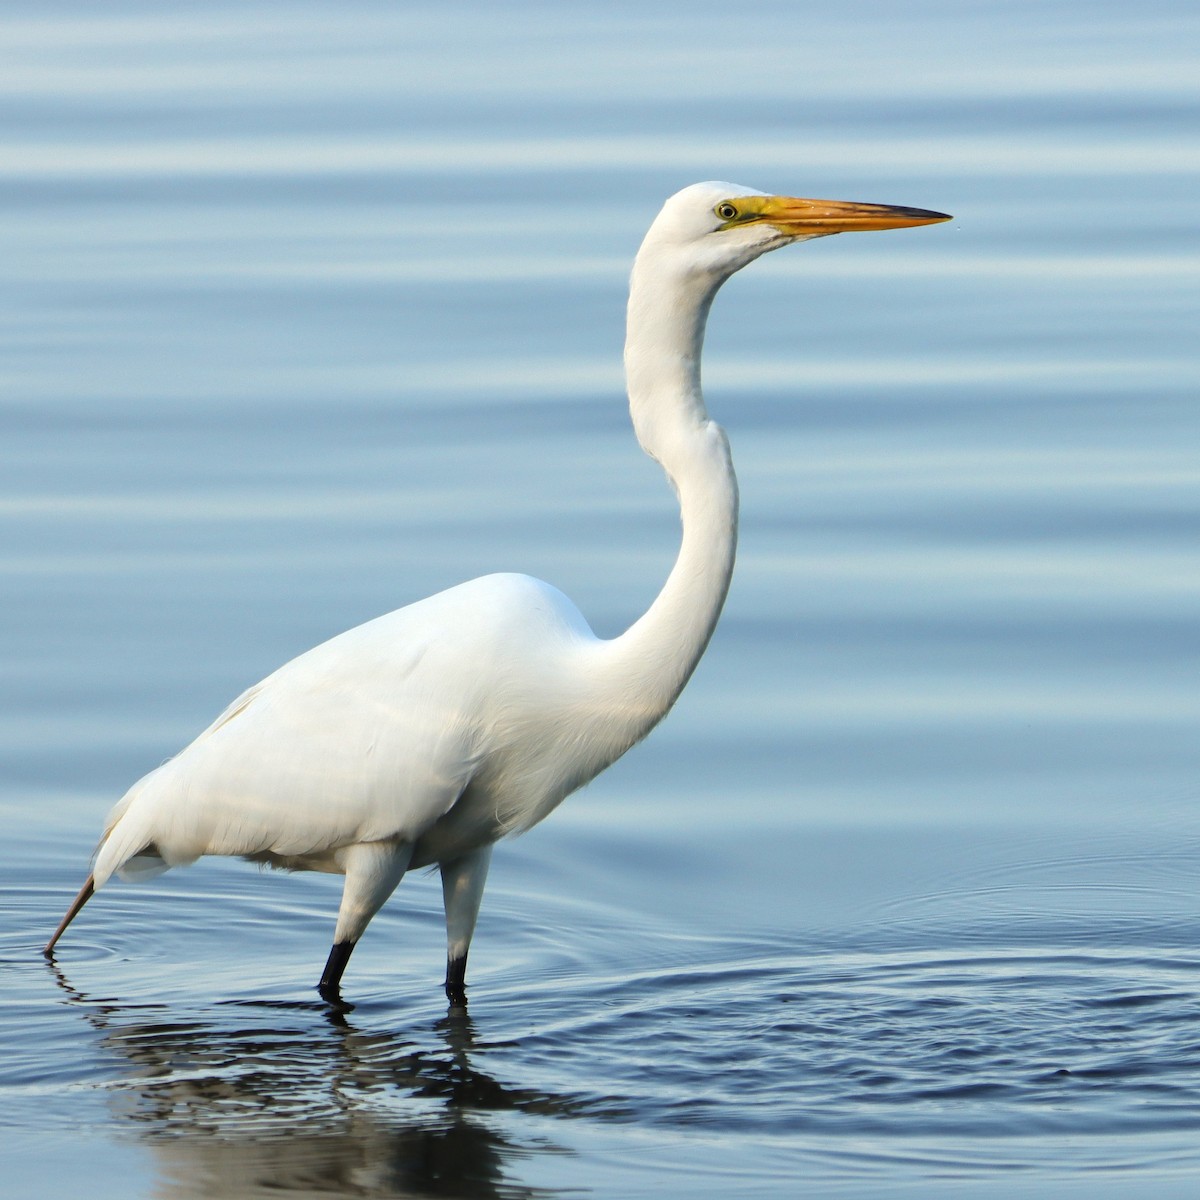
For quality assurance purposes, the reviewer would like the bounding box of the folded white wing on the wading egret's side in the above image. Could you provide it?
[95,600,479,886]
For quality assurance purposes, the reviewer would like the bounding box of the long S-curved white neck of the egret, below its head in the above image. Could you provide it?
[605,248,738,744]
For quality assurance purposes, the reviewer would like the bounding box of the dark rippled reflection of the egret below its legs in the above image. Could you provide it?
[55,967,592,1200]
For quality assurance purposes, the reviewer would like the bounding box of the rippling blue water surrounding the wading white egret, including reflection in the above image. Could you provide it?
[0,0,1200,1200]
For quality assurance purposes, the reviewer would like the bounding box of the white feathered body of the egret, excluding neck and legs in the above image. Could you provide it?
[95,575,612,887]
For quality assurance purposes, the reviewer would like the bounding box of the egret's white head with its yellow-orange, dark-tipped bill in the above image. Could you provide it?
[642,182,950,281]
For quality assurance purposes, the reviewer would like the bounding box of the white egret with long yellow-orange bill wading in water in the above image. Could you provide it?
[44,182,949,1004]
